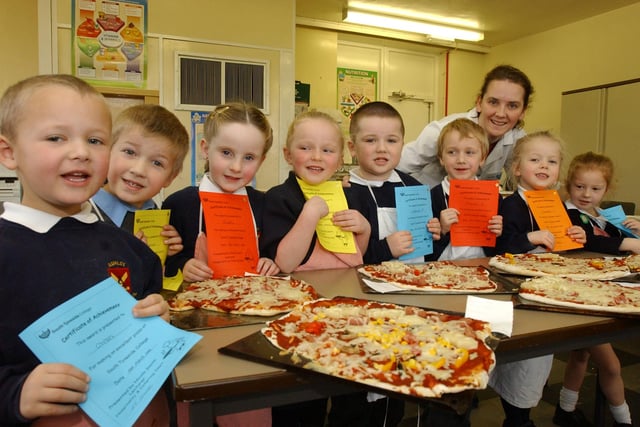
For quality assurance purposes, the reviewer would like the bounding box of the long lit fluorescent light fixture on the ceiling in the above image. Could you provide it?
[343,9,484,41]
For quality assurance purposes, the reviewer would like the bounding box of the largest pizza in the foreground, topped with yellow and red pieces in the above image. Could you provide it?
[262,297,495,397]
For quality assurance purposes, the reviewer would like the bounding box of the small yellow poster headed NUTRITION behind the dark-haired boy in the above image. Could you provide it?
[338,68,378,117]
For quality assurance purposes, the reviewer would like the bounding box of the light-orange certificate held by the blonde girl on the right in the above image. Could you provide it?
[524,190,582,251]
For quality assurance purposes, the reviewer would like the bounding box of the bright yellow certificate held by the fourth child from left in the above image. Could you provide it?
[298,179,357,254]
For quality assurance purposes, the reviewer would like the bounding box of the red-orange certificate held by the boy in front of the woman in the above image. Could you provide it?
[449,179,500,246]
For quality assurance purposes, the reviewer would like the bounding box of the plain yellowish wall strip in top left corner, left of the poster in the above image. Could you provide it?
[0,0,38,93]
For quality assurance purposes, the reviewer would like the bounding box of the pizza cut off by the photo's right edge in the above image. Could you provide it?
[519,276,640,314]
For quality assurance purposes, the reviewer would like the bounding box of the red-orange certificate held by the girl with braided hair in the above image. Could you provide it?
[200,191,259,278]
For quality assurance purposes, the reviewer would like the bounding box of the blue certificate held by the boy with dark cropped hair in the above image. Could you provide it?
[395,185,433,260]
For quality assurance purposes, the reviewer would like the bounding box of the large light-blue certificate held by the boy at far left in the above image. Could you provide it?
[20,278,202,426]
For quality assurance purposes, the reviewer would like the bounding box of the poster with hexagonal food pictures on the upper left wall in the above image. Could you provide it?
[71,0,147,88]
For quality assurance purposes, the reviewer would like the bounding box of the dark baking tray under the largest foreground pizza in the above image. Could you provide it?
[218,331,476,414]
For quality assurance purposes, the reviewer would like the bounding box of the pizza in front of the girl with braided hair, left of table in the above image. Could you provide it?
[168,276,318,316]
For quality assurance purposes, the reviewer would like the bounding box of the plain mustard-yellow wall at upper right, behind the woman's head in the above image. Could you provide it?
[485,3,640,137]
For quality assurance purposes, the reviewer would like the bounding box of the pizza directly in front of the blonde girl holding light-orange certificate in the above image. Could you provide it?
[489,253,630,280]
